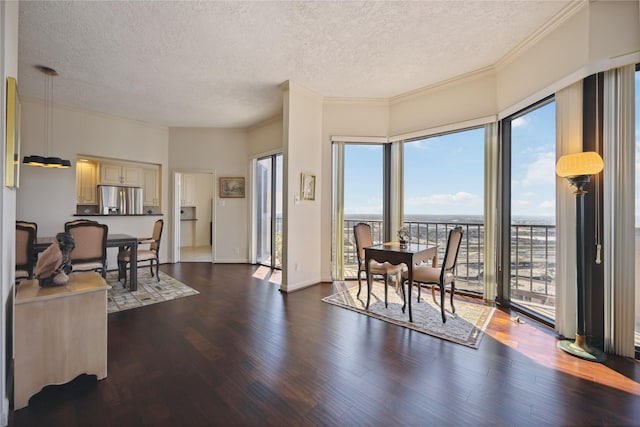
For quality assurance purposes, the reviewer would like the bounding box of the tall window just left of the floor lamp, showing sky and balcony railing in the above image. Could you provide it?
[506,99,556,322]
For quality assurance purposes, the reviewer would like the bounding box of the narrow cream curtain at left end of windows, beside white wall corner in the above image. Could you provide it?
[331,142,344,280]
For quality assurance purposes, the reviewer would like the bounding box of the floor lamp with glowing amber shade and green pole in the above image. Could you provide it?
[556,151,607,362]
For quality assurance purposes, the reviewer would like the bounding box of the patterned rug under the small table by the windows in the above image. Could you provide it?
[322,281,495,349]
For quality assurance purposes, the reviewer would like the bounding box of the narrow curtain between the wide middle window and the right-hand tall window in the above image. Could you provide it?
[483,122,499,301]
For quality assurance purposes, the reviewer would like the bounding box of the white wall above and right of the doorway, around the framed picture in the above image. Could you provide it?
[169,128,249,263]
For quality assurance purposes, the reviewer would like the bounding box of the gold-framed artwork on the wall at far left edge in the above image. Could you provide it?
[4,77,20,188]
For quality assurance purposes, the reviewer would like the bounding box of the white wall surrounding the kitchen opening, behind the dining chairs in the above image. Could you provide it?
[16,101,171,270]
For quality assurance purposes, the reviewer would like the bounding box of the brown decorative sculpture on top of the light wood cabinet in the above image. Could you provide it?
[35,233,76,287]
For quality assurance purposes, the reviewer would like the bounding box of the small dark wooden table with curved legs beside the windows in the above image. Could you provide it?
[364,242,438,322]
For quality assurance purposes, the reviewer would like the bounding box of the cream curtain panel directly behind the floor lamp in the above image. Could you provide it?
[555,81,583,338]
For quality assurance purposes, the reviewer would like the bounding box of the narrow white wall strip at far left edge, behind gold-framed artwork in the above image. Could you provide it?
[0,0,20,426]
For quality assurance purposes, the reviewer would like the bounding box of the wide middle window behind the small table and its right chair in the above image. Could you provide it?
[403,127,485,293]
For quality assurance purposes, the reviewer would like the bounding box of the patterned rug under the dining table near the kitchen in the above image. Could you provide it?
[107,268,199,313]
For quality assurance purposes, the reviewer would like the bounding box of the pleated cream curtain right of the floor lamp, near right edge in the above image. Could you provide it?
[602,65,635,357]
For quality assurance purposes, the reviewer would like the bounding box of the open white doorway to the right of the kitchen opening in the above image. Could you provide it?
[174,171,215,262]
